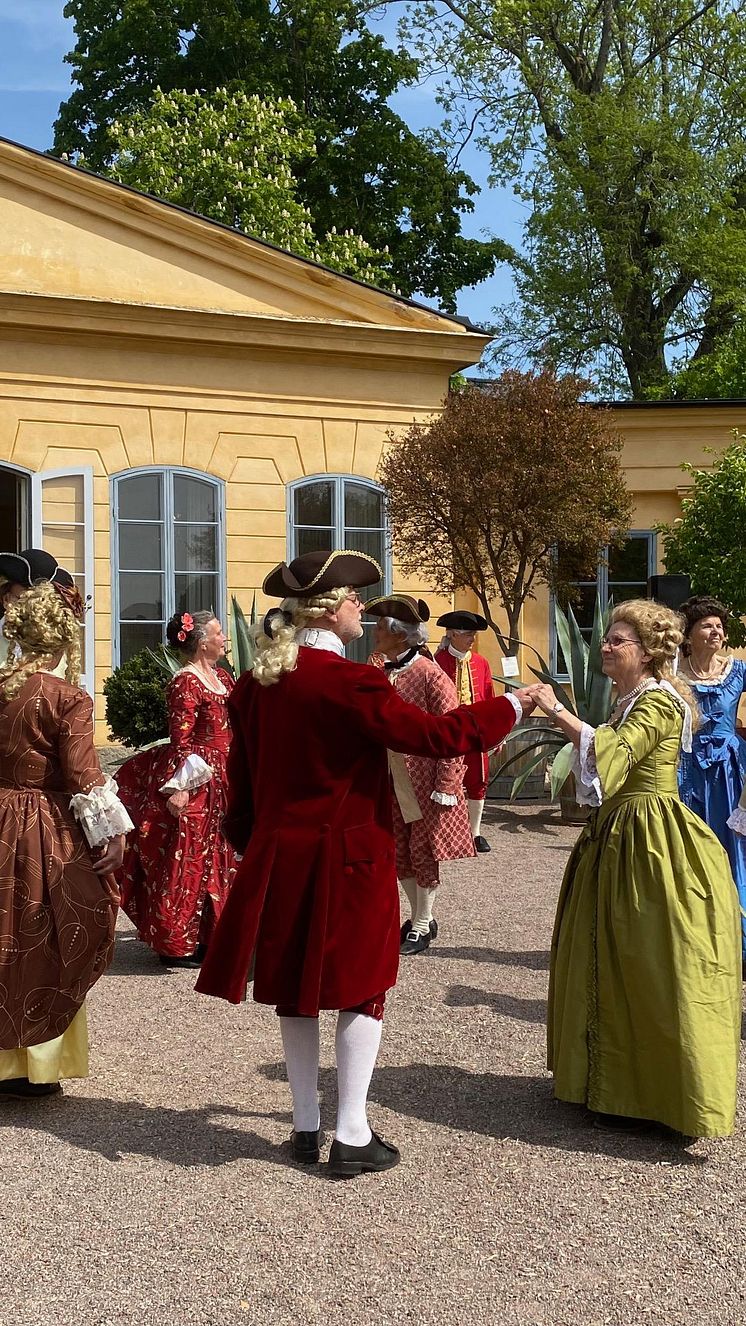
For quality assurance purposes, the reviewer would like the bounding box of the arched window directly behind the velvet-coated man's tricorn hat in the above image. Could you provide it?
[288,475,391,660]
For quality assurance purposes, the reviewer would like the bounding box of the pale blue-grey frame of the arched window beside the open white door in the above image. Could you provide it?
[110,465,227,667]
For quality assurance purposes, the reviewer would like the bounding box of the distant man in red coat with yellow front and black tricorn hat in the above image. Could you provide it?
[435,610,494,851]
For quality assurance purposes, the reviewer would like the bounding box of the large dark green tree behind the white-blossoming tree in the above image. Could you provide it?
[54,0,506,309]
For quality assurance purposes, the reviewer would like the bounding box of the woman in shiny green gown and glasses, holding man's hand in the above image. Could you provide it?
[533,599,741,1138]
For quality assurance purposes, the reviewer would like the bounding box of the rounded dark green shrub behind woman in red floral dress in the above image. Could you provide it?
[103,648,168,749]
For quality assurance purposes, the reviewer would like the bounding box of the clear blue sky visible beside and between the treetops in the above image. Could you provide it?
[0,0,521,324]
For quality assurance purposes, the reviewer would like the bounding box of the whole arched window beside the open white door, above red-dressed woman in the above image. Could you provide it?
[111,468,225,664]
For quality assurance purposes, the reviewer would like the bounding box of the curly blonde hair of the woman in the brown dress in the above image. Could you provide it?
[0,581,81,700]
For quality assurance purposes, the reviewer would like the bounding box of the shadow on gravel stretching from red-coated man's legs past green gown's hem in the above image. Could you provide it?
[260,1063,706,1166]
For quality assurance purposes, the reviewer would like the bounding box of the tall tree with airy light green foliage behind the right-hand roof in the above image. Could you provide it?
[408,0,746,396]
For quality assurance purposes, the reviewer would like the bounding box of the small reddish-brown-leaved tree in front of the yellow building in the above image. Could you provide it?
[379,370,632,654]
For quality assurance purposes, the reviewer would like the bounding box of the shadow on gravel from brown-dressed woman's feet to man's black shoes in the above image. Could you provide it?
[0,1095,316,1168]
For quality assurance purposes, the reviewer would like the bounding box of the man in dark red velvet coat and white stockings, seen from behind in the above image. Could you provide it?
[197,552,533,1176]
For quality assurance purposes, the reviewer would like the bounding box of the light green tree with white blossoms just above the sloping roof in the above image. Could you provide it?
[103,88,391,285]
